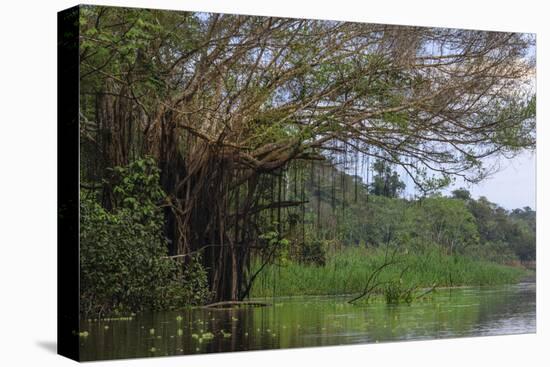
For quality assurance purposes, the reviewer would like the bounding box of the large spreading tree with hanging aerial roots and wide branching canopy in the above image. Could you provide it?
[80,7,535,300]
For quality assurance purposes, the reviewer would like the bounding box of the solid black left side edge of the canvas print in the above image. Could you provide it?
[57,5,80,361]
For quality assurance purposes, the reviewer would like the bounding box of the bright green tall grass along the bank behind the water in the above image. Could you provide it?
[250,248,525,297]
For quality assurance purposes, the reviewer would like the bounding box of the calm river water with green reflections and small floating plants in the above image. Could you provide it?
[80,283,536,360]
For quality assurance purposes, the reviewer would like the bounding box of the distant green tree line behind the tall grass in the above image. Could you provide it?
[289,164,536,264]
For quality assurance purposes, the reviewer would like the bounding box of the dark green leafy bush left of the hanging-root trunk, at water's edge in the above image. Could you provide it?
[80,158,208,316]
